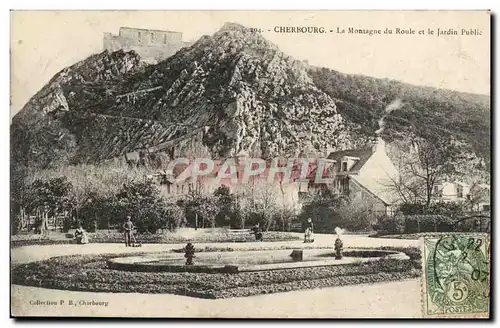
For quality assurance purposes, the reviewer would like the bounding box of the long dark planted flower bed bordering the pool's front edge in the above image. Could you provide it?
[12,247,421,298]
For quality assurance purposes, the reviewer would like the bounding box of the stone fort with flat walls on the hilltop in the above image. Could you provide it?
[103,27,192,63]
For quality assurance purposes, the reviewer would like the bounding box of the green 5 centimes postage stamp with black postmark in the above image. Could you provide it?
[422,234,490,318]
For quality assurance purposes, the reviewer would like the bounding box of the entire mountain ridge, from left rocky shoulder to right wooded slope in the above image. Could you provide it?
[11,24,489,172]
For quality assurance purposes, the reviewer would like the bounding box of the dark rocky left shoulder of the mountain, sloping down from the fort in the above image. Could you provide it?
[11,51,144,167]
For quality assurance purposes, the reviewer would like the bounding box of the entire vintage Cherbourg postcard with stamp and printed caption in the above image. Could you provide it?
[10,10,492,319]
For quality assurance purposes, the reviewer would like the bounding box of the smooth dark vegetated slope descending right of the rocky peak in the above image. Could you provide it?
[309,68,491,160]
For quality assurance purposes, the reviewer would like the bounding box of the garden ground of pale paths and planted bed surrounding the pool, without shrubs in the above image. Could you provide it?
[11,233,420,317]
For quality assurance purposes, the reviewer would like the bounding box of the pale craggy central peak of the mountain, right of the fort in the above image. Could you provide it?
[92,24,358,157]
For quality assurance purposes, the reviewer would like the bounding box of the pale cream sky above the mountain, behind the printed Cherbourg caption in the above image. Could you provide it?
[10,11,490,117]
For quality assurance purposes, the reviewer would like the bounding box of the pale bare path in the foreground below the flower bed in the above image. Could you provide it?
[11,279,421,318]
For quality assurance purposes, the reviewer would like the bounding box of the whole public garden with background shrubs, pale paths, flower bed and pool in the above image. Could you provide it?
[11,170,490,317]
